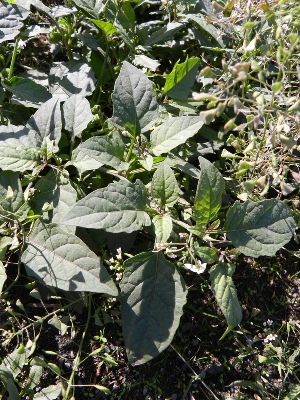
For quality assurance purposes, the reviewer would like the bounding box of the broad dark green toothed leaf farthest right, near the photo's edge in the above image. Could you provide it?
[224,199,296,257]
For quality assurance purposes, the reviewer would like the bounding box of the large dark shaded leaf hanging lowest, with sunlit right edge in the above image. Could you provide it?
[120,252,187,365]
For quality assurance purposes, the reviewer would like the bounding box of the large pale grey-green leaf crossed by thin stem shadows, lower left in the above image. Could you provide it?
[22,223,118,296]
